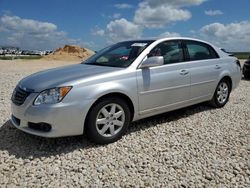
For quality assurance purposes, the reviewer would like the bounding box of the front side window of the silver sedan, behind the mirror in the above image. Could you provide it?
[148,41,184,64]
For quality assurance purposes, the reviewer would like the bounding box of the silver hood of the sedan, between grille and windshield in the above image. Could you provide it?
[18,64,121,92]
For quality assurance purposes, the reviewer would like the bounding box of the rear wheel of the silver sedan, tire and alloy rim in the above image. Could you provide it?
[210,79,231,108]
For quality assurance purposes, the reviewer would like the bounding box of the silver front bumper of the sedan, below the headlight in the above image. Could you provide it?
[11,93,93,137]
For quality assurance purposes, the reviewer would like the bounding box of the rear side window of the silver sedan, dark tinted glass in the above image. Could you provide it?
[186,41,218,61]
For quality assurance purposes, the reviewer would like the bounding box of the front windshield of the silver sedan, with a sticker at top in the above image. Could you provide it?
[83,40,153,67]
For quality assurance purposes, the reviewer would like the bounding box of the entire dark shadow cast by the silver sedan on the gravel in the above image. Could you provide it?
[0,104,213,159]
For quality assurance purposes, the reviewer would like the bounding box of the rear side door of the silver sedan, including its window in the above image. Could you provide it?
[184,41,222,100]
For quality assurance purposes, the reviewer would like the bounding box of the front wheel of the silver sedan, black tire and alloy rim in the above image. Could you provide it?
[85,97,131,144]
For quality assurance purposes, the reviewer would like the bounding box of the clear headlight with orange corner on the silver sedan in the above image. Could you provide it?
[34,86,72,105]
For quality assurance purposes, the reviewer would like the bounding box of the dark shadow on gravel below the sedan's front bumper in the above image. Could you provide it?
[0,120,95,159]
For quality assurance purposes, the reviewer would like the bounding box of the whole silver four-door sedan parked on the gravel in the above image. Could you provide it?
[11,37,241,144]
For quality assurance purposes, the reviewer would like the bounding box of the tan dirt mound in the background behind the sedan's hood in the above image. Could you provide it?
[44,45,94,61]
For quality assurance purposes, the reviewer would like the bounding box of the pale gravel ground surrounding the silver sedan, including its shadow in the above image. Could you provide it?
[0,61,250,187]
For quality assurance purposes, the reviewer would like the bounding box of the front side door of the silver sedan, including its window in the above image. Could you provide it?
[137,41,190,115]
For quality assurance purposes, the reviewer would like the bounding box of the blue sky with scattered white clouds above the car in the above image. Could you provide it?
[0,0,250,51]
